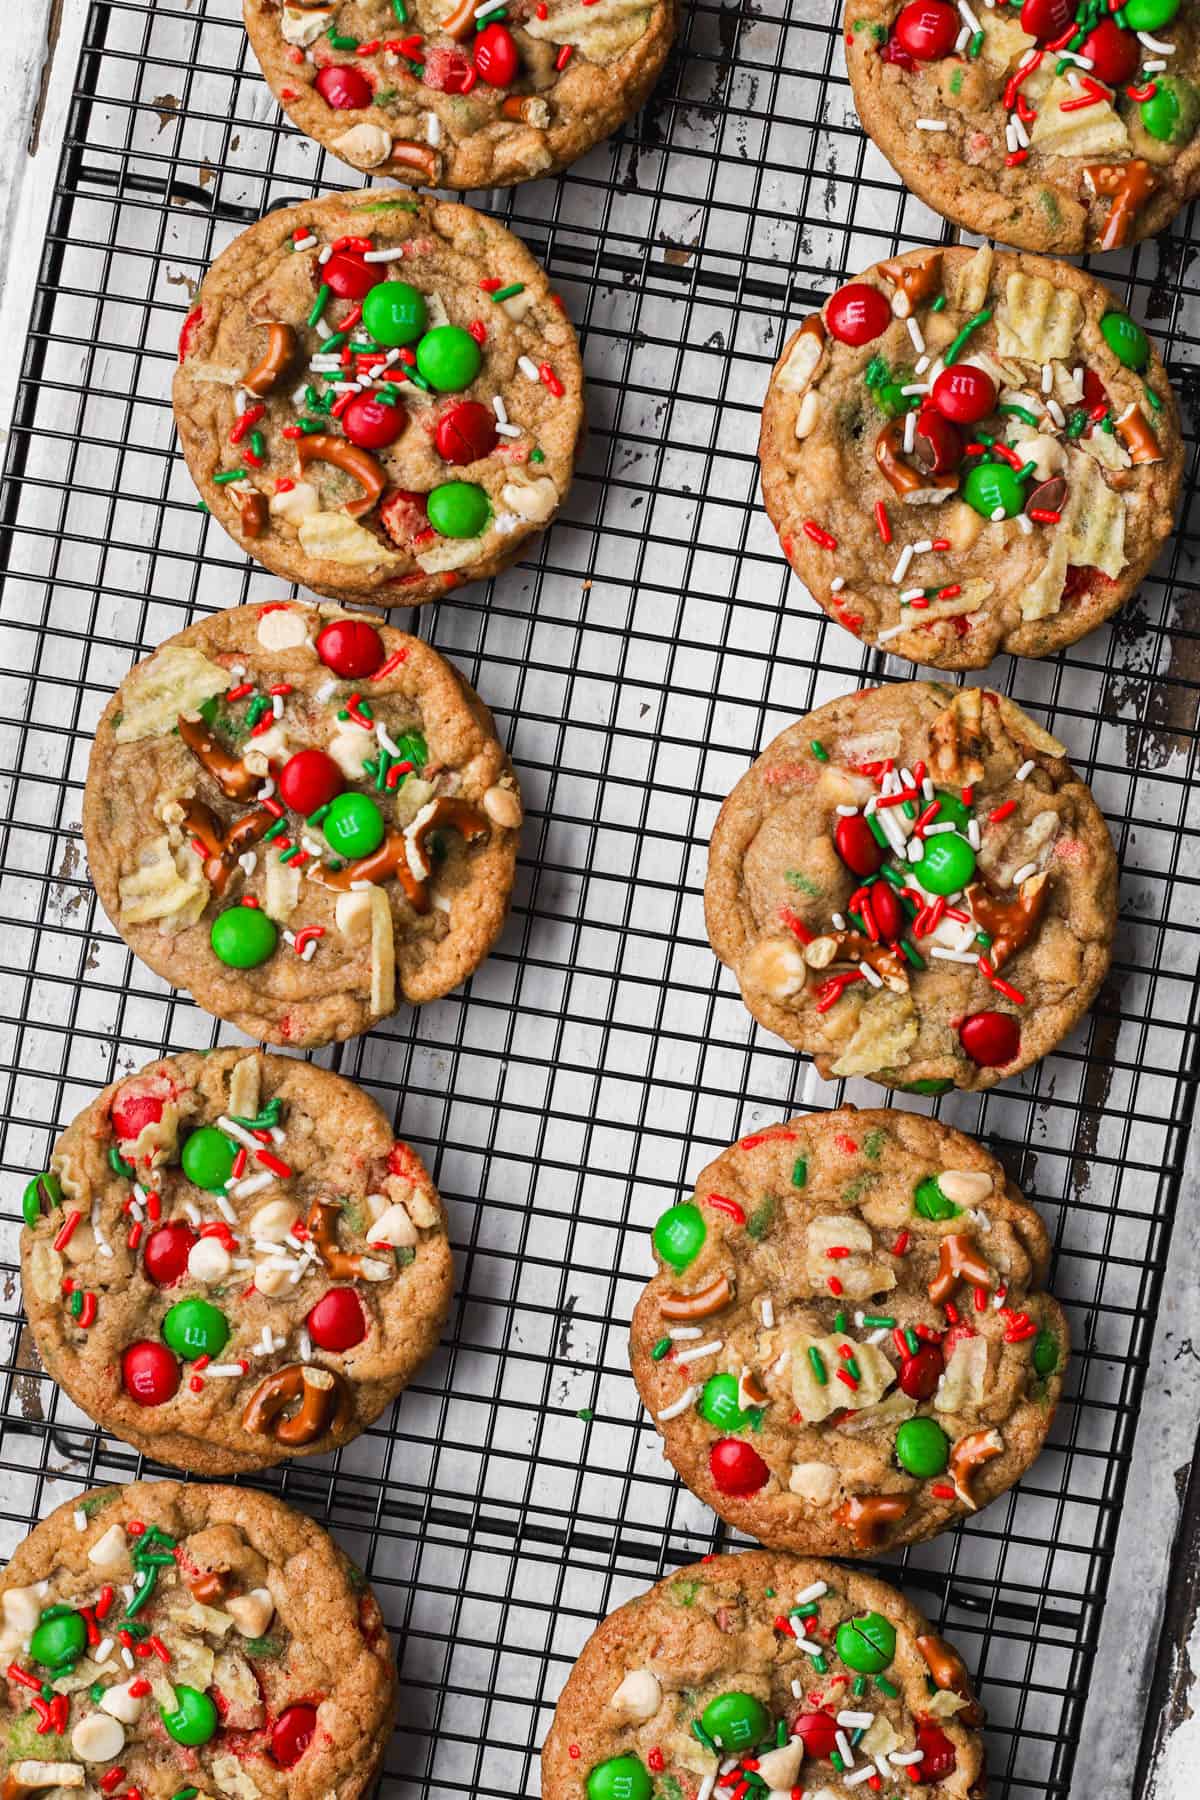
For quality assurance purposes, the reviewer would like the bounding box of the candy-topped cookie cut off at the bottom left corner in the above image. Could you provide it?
[0,1481,396,1800]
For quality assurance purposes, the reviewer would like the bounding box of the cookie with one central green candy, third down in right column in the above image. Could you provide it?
[703,682,1117,1094]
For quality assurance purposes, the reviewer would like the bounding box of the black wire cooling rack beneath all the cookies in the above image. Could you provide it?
[0,0,1200,1796]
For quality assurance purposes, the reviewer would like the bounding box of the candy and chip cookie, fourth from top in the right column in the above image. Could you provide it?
[631,1107,1067,1557]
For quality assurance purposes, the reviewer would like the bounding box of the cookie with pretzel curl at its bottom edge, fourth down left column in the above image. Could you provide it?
[22,1049,453,1474]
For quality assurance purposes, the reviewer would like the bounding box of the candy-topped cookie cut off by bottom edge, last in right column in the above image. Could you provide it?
[542,1550,988,1800]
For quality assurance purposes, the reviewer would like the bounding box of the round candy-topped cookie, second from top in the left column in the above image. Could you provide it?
[173,187,583,607]
